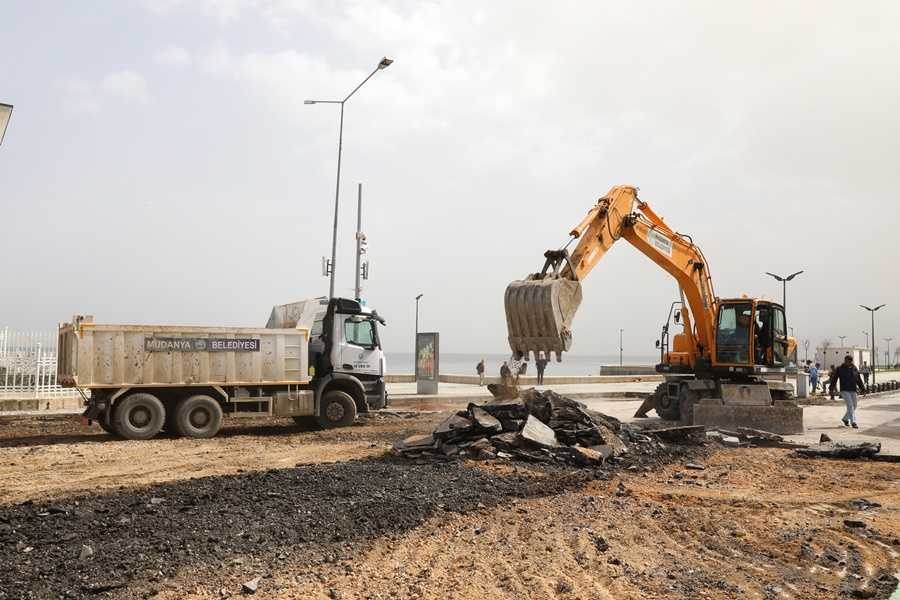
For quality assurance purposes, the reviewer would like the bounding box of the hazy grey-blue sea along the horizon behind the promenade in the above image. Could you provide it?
[385,352,659,375]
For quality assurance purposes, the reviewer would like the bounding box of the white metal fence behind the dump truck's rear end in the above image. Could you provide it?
[0,327,78,400]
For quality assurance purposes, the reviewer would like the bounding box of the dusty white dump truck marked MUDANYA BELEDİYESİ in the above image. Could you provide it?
[57,298,388,440]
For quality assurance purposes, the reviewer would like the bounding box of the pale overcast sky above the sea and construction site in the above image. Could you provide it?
[0,0,900,358]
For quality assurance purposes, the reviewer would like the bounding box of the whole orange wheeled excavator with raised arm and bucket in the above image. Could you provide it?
[505,185,803,433]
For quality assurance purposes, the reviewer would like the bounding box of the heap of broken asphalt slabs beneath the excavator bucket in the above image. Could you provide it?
[394,389,653,466]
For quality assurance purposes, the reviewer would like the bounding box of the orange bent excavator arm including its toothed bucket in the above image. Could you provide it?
[505,185,716,363]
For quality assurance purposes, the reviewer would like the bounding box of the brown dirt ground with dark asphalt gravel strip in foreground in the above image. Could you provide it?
[0,414,900,600]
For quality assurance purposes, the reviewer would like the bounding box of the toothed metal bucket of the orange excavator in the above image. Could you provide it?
[504,277,581,361]
